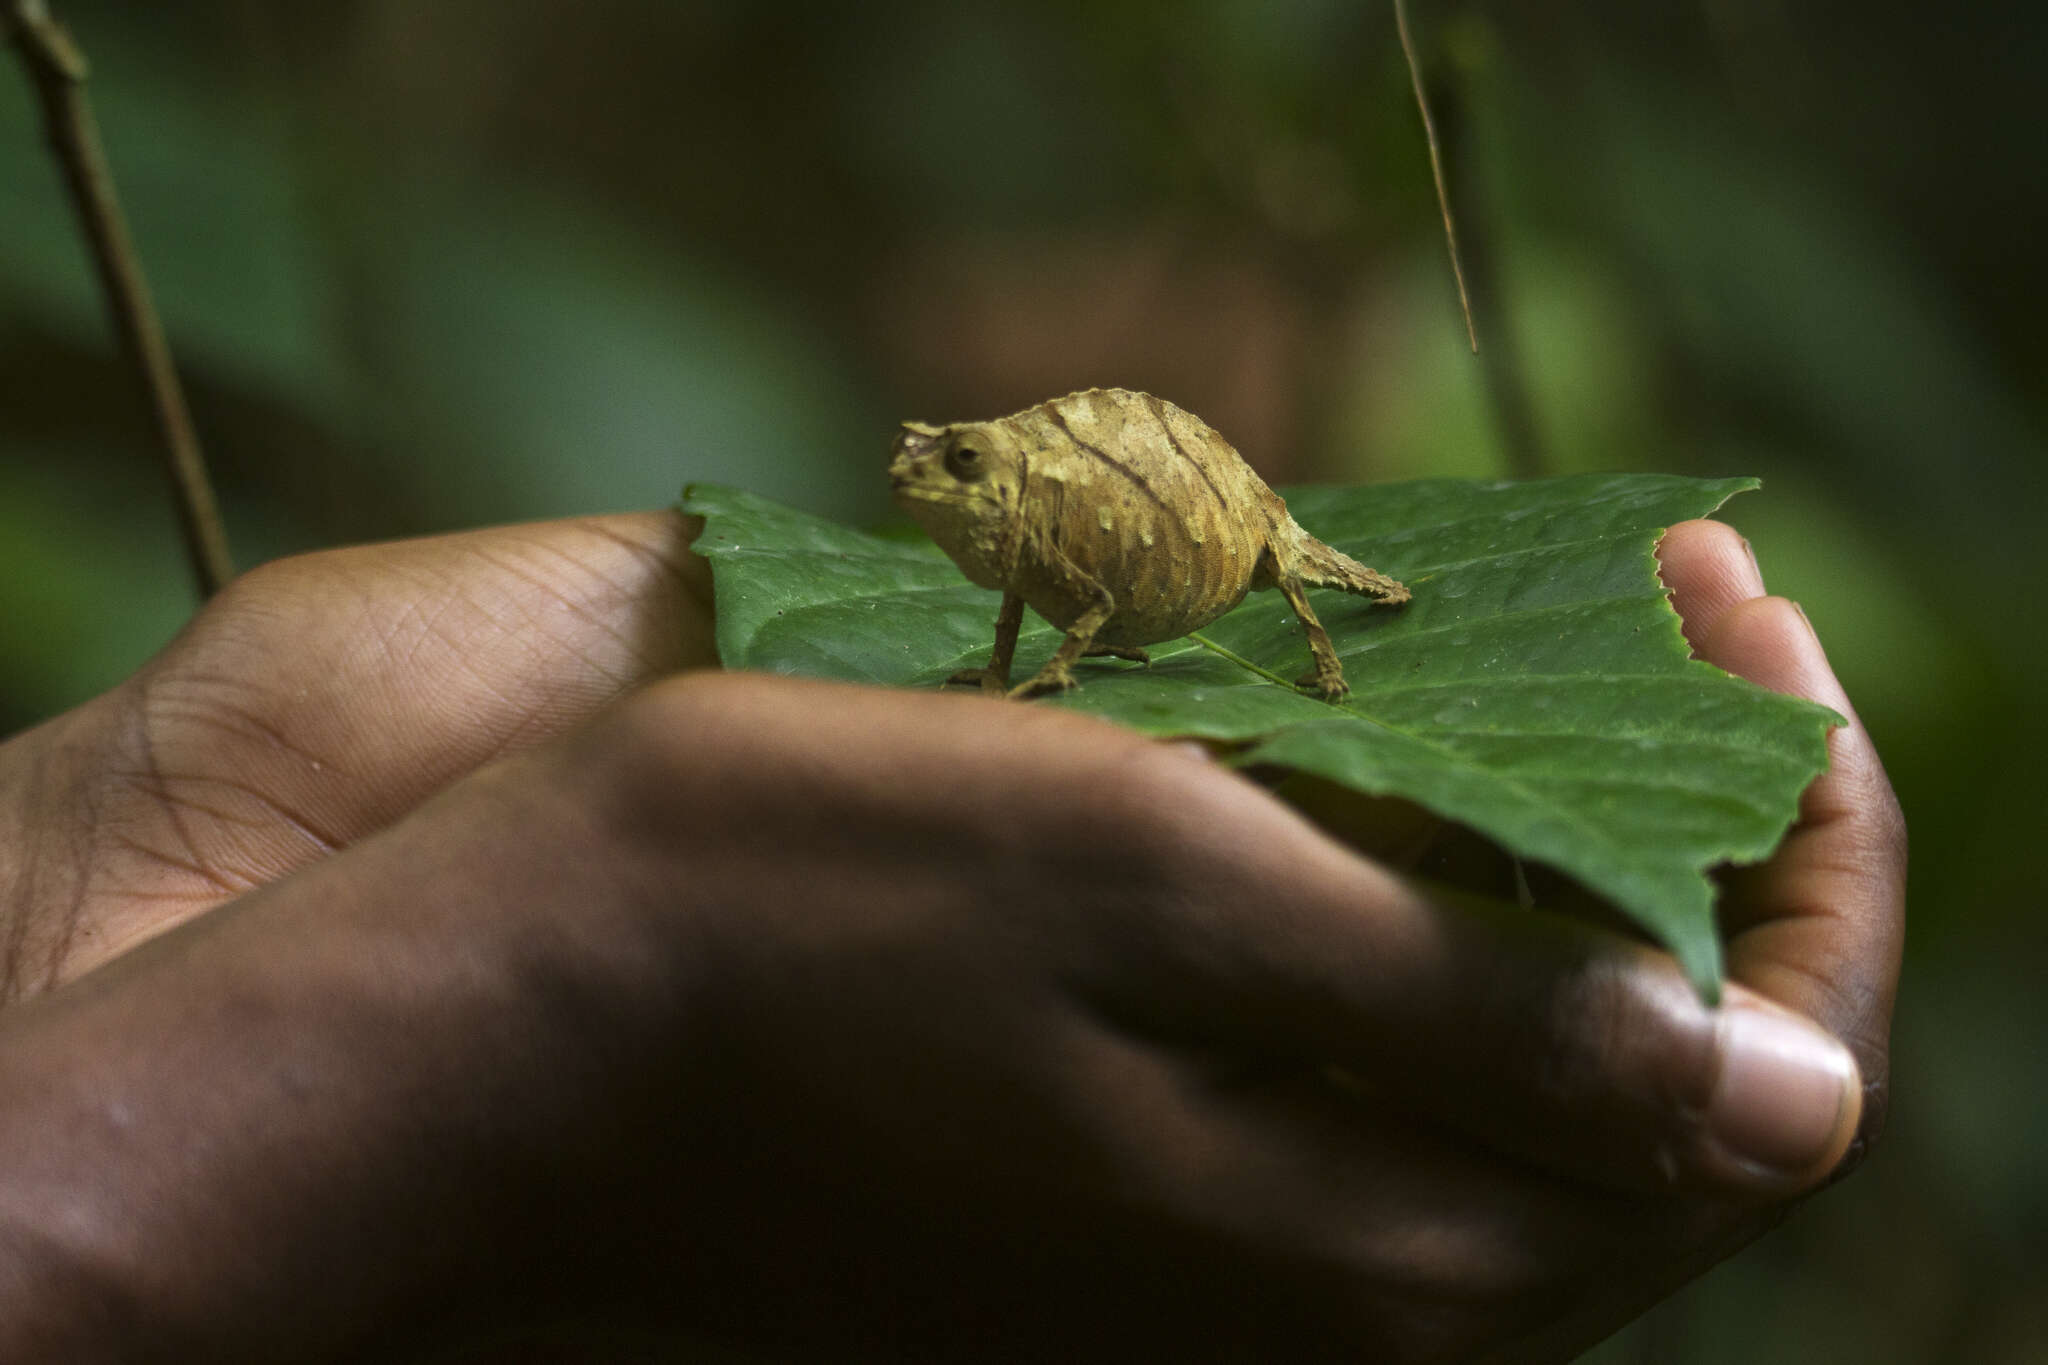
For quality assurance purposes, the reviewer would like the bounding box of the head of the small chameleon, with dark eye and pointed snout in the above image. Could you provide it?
[889,422,1024,587]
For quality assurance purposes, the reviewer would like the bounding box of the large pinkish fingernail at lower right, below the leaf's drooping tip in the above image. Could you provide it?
[1706,1009,1860,1175]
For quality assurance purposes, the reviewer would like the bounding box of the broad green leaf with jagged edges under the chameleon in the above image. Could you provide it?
[684,475,1841,997]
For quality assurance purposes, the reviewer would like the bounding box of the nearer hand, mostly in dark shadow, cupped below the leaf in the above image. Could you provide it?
[0,517,1888,1359]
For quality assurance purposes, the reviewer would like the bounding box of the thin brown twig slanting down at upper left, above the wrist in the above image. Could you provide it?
[8,0,233,598]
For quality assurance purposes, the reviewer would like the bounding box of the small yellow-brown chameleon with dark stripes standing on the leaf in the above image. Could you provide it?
[889,389,1409,698]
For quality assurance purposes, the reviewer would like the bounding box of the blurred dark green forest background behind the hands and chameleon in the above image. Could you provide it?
[0,0,2048,1365]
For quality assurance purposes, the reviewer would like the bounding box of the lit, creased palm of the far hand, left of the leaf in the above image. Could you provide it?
[45,512,713,984]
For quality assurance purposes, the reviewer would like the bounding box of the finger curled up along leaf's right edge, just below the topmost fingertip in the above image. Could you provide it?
[1704,598,1907,1140]
